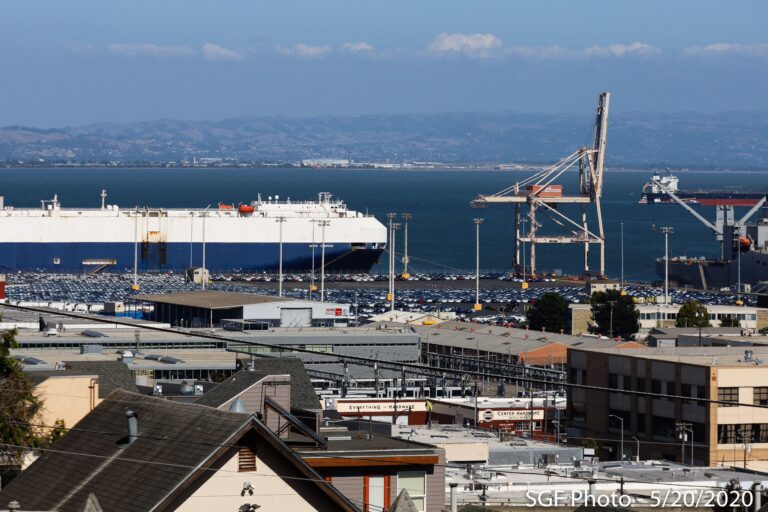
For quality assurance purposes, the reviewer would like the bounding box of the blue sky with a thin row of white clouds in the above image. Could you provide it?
[0,0,768,128]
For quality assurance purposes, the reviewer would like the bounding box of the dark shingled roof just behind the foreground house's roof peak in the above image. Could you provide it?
[195,357,320,409]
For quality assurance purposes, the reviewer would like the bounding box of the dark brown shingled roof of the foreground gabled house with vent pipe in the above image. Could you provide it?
[0,390,355,512]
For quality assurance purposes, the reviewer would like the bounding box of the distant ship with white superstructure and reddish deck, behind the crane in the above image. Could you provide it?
[639,174,765,206]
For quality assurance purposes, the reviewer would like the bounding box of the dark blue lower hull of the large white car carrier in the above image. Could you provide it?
[0,242,383,272]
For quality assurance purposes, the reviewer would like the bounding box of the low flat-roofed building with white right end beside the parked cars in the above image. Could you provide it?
[135,290,350,331]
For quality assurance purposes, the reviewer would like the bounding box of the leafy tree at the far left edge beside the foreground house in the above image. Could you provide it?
[0,329,47,470]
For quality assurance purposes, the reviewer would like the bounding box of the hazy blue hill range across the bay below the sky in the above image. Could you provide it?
[0,112,768,168]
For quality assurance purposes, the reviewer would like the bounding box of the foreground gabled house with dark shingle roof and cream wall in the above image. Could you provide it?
[0,390,358,512]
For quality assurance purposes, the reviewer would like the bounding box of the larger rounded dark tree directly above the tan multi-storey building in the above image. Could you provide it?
[590,290,640,340]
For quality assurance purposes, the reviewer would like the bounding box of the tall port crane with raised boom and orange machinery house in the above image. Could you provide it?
[470,92,610,276]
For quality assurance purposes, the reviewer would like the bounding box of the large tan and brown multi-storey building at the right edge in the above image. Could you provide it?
[568,346,768,469]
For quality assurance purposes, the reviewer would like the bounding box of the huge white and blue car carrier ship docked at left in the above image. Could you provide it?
[0,191,387,272]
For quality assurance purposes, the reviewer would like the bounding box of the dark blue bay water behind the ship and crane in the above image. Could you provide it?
[0,169,768,280]
